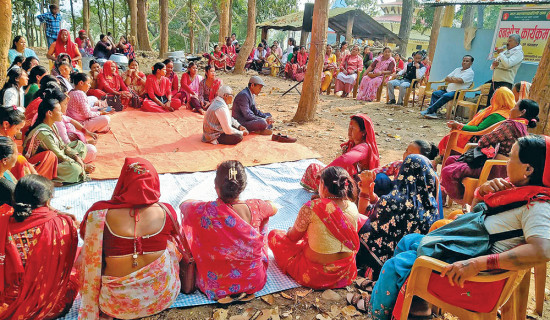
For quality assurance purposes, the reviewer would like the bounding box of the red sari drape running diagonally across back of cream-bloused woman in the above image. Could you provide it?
[305,198,359,252]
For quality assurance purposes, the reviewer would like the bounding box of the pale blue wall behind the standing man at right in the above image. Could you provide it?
[430,28,538,95]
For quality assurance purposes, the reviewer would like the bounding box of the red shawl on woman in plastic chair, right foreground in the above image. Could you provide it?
[475,136,550,208]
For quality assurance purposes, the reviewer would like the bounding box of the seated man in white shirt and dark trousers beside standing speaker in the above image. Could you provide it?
[420,55,474,119]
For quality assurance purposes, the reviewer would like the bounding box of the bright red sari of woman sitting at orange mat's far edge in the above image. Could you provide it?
[141,74,181,112]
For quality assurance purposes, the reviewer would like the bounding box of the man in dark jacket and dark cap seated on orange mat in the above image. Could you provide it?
[232,76,273,135]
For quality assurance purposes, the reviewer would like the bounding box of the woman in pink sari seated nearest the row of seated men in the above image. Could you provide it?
[357,47,395,102]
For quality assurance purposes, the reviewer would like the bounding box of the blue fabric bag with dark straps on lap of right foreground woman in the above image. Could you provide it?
[416,201,527,263]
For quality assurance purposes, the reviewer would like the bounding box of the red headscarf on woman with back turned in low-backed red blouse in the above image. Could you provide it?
[80,158,160,239]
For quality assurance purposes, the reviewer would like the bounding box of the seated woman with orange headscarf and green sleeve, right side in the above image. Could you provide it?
[438,87,516,155]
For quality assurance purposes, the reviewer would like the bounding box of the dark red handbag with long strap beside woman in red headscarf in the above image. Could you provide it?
[158,202,197,294]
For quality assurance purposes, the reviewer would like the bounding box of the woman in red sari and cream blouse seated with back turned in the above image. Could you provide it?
[268,167,359,289]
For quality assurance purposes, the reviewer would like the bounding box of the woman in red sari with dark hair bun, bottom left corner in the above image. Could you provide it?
[0,175,78,319]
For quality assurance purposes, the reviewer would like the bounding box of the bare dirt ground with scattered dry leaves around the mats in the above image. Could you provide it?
[36,49,550,320]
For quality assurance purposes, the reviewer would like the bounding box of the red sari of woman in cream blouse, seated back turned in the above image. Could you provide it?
[268,199,359,290]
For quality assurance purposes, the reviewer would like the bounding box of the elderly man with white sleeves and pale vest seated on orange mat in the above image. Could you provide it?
[202,86,248,145]
